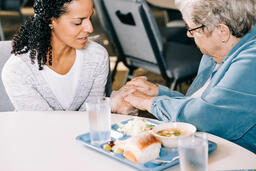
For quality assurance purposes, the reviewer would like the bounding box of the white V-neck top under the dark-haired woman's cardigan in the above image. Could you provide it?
[41,50,82,109]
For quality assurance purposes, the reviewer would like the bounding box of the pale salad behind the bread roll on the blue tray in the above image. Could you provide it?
[117,117,155,136]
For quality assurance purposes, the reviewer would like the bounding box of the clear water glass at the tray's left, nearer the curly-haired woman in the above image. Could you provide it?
[86,97,111,145]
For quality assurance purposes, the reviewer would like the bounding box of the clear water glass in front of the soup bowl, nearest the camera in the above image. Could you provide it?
[178,132,208,171]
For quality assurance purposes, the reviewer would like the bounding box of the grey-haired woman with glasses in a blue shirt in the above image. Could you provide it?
[121,0,256,153]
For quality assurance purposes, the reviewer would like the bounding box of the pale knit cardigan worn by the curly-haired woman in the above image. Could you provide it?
[2,41,109,111]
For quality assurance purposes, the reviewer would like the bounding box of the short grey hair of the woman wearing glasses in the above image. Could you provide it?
[175,0,256,37]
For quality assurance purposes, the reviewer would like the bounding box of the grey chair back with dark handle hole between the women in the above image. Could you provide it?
[103,0,163,68]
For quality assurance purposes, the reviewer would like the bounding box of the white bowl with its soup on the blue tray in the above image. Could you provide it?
[152,122,196,148]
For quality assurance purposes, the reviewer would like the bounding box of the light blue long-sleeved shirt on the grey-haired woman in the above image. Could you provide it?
[151,26,256,153]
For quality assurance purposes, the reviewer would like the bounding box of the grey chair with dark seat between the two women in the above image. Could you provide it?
[95,0,202,89]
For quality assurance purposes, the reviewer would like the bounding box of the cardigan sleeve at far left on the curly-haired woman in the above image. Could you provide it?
[2,56,53,111]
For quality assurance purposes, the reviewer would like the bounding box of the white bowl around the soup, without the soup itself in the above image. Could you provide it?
[151,122,196,148]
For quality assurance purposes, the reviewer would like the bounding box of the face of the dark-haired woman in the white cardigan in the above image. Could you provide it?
[51,0,93,49]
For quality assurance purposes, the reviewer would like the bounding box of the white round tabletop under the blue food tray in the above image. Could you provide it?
[0,112,256,171]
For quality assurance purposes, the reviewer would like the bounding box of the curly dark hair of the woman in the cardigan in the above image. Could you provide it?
[11,0,72,70]
